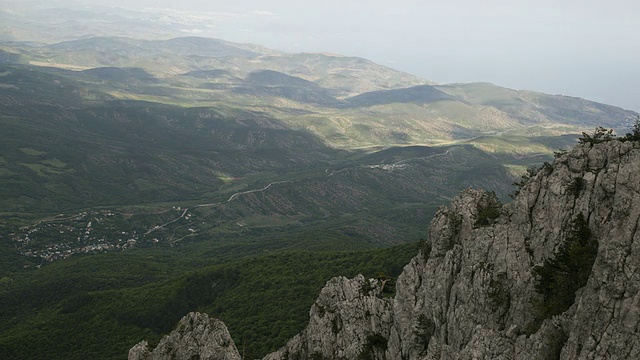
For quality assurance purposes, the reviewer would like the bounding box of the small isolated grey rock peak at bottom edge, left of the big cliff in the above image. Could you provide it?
[129,313,240,360]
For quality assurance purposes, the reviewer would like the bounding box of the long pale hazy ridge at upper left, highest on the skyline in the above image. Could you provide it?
[0,37,428,95]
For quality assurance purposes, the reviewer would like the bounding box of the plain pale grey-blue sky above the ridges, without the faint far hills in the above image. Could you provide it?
[35,0,640,111]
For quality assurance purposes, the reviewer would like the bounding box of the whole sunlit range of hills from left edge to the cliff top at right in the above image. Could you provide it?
[0,37,636,153]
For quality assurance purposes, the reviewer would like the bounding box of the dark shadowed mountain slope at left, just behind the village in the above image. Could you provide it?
[0,67,338,211]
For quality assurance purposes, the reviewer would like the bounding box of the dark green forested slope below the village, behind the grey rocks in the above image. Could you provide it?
[0,243,418,359]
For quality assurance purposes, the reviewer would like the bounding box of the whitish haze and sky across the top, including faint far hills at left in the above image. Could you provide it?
[5,0,640,111]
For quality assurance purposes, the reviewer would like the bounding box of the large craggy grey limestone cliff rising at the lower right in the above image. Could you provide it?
[130,141,640,360]
